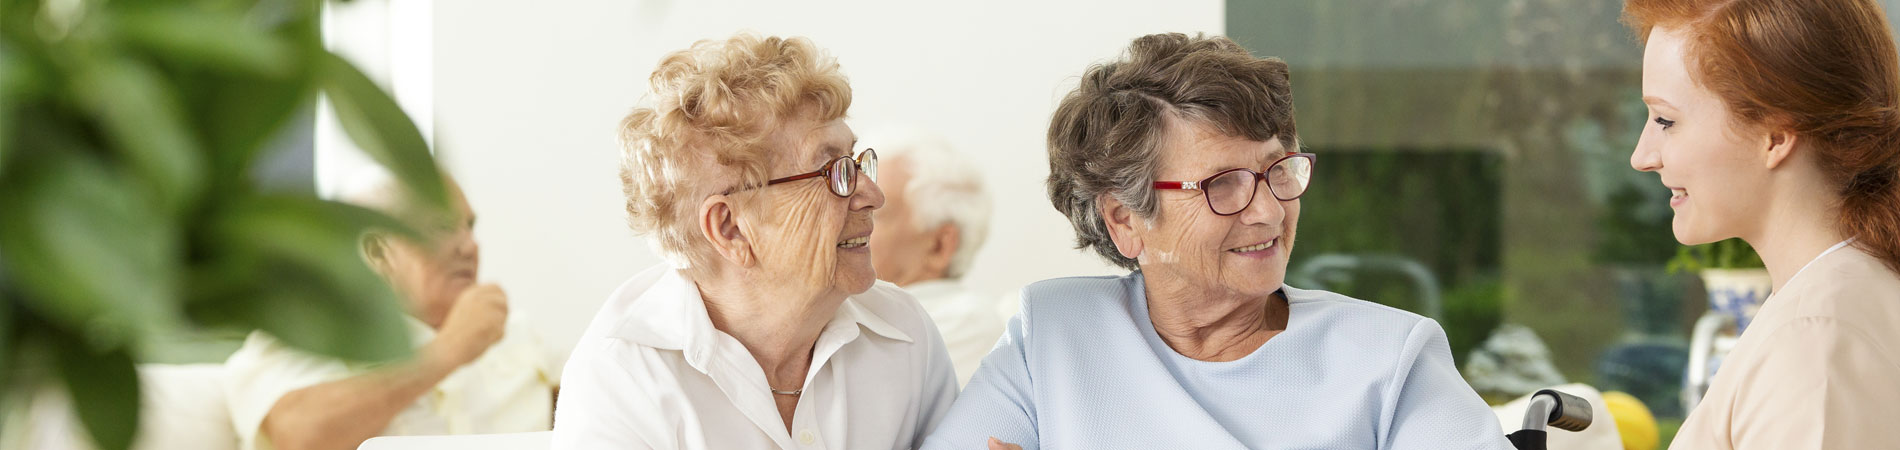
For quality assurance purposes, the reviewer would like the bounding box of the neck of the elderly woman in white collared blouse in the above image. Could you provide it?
[699,273,844,389]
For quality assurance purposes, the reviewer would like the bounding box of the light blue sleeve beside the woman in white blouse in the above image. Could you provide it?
[923,313,1039,450]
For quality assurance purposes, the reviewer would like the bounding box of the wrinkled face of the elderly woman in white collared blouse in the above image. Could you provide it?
[739,112,884,300]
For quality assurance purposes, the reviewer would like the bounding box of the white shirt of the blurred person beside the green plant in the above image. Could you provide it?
[224,315,561,450]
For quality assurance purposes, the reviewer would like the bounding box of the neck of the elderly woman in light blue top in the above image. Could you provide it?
[1146,271,1288,363]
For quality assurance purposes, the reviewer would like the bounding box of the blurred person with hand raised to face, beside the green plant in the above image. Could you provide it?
[226,177,561,450]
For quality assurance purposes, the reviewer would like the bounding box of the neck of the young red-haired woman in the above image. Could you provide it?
[1742,183,1847,291]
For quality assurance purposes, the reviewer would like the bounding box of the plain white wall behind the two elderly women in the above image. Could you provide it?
[433,0,1224,358]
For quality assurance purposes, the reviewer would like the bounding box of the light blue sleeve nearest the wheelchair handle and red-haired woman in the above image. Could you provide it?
[1381,319,1512,450]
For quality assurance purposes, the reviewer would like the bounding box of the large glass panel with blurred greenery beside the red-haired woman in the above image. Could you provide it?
[1226,0,1854,444]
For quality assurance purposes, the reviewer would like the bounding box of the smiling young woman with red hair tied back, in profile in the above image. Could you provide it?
[1625,0,1900,448]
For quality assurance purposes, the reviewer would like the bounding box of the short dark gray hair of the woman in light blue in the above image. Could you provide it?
[1049,32,1300,270]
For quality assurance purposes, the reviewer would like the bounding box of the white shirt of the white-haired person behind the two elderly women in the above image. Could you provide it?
[904,279,1009,385]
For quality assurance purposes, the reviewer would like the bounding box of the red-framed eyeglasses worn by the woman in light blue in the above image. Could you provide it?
[1155,154,1315,216]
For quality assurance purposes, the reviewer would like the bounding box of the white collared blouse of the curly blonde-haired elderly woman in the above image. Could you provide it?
[553,266,958,448]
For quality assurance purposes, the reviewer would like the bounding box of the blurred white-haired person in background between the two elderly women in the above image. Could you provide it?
[865,129,1007,385]
